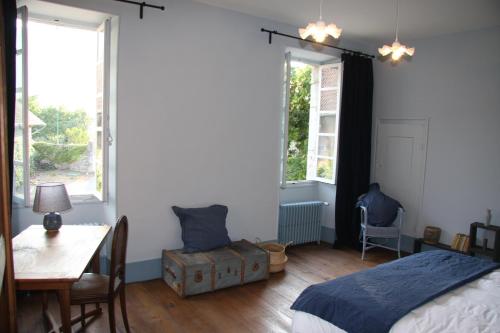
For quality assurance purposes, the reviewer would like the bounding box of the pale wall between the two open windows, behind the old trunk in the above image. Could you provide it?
[12,0,372,262]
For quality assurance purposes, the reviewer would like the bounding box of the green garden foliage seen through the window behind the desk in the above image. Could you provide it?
[29,97,90,170]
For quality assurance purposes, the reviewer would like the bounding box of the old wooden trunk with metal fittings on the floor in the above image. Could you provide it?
[162,240,269,297]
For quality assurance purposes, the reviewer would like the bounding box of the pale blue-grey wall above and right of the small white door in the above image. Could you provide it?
[374,28,500,243]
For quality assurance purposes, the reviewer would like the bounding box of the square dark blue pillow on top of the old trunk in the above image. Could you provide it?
[172,205,231,253]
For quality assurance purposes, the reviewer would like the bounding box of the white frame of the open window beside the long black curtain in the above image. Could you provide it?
[281,57,343,188]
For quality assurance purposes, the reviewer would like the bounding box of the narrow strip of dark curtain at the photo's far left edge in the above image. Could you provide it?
[2,0,17,197]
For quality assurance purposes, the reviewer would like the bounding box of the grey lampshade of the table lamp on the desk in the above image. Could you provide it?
[33,183,71,213]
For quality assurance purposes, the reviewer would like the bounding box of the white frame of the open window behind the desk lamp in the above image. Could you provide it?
[13,6,113,208]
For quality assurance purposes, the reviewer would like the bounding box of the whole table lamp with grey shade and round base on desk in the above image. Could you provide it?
[33,183,71,231]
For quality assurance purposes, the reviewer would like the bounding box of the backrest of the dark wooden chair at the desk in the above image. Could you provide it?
[109,215,128,294]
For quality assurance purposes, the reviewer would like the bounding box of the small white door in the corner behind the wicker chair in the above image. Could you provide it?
[372,119,428,237]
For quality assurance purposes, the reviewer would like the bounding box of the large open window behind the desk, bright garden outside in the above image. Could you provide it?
[13,7,109,207]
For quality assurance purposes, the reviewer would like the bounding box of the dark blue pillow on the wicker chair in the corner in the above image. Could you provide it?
[356,183,402,227]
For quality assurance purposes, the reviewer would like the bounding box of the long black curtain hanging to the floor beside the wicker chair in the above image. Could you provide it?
[335,54,373,249]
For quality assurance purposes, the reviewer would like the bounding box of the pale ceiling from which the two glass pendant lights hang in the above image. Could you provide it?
[192,0,500,42]
